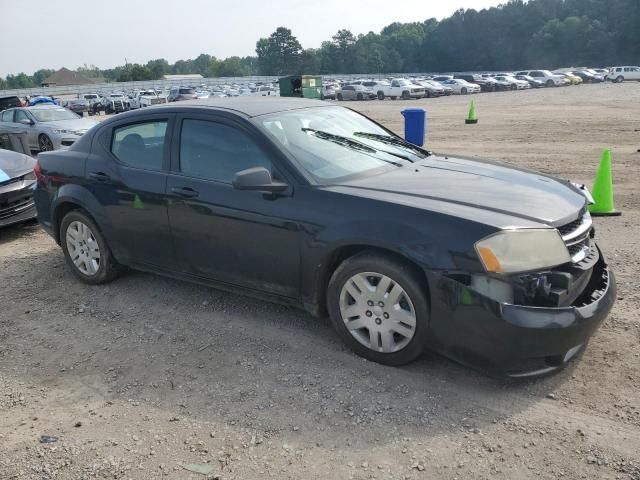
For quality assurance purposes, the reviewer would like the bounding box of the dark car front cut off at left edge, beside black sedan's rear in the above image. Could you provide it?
[0,149,36,227]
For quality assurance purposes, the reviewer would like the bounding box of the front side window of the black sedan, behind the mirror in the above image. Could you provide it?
[180,119,271,183]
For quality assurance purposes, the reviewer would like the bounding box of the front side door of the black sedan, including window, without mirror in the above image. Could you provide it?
[167,114,300,298]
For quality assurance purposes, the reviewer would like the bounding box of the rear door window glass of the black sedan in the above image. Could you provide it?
[111,120,167,170]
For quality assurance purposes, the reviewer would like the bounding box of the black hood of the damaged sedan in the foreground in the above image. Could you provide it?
[330,155,586,228]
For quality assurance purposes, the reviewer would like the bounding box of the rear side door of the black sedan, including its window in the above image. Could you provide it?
[86,114,177,270]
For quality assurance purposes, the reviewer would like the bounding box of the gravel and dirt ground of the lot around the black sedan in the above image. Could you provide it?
[0,83,640,480]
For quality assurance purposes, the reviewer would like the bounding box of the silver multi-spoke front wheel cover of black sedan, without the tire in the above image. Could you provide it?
[340,272,416,353]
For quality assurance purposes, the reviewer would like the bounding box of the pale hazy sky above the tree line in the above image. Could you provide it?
[0,0,506,77]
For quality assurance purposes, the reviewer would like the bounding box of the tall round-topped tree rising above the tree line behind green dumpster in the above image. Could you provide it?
[256,27,302,75]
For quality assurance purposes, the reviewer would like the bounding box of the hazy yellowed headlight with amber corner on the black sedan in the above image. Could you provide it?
[475,229,571,273]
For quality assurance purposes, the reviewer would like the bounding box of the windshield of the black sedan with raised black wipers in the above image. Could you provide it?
[256,107,424,184]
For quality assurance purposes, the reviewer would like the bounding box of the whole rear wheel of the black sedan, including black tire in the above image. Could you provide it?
[60,210,122,285]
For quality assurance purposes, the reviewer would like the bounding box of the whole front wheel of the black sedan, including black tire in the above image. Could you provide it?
[327,251,429,365]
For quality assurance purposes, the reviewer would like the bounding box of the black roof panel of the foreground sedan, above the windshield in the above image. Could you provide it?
[155,97,330,117]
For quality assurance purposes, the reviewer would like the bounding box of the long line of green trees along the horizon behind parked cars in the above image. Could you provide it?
[0,0,640,89]
